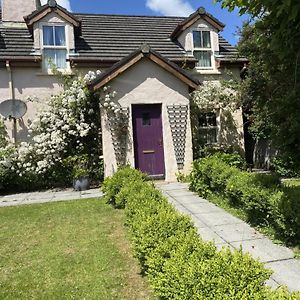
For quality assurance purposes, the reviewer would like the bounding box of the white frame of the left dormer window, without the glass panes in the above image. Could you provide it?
[39,22,71,74]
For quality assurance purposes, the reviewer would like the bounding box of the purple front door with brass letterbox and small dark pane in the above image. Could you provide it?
[132,104,165,177]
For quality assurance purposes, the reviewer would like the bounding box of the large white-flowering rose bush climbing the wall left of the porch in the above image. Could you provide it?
[0,71,118,189]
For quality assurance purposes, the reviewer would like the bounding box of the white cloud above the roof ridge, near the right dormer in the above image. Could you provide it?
[146,0,195,17]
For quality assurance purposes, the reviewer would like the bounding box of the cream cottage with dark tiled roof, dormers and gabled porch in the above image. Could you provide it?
[0,0,245,181]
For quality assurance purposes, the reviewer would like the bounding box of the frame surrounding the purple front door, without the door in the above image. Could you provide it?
[130,103,167,180]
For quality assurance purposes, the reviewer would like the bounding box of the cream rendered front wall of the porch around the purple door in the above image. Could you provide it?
[102,59,193,181]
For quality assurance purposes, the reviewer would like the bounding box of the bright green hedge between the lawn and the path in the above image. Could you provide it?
[103,167,299,300]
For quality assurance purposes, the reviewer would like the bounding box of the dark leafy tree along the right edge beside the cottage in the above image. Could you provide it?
[218,0,300,172]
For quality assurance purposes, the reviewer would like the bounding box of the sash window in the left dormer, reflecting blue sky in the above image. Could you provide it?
[42,25,67,70]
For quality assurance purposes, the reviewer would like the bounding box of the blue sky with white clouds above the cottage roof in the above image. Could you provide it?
[42,0,247,44]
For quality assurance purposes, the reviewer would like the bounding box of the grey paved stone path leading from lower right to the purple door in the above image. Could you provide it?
[157,183,300,291]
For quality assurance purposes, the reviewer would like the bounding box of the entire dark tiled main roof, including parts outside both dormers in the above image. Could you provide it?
[0,13,246,64]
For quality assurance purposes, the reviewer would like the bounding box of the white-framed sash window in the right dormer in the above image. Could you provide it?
[193,30,212,69]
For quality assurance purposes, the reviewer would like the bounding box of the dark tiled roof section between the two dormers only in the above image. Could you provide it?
[72,14,190,61]
